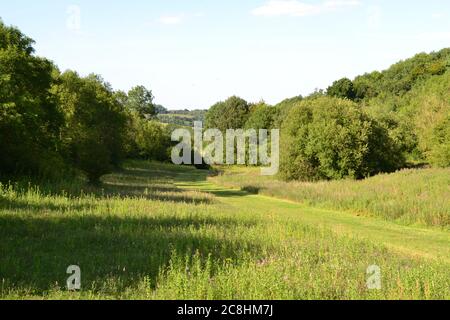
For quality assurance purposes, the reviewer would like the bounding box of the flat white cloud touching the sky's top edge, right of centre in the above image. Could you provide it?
[252,0,361,17]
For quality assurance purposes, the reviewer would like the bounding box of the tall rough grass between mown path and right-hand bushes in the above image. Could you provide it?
[213,167,450,231]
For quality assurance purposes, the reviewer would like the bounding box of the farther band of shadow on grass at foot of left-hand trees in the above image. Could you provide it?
[0,161,218,211]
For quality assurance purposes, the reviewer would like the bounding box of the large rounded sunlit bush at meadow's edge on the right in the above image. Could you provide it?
[281,97,403,180]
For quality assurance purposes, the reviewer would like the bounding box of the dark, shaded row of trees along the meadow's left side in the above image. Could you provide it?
[0,21,171,183]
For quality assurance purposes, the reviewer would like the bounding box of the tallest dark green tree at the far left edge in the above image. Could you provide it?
[0,21,64,176]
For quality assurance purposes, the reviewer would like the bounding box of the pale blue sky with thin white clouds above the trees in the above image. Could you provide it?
[0,0,450,110]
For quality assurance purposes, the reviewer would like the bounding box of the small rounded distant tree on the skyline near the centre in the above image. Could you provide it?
[205,96,250,132]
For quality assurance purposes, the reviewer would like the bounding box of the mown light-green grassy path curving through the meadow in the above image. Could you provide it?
[176,173,450,264]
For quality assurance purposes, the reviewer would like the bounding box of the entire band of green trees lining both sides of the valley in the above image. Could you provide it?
[0,21,450,183]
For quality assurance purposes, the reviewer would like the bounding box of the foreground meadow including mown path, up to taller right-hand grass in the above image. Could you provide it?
[0,161,450,299]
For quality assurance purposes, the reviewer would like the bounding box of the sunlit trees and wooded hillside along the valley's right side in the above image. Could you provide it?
[206,49,450,181]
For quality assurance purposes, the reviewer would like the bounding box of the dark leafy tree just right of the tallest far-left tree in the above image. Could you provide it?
[53,71,126,183]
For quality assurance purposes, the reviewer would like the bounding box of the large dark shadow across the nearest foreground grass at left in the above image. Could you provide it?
[0,216,261,297]
